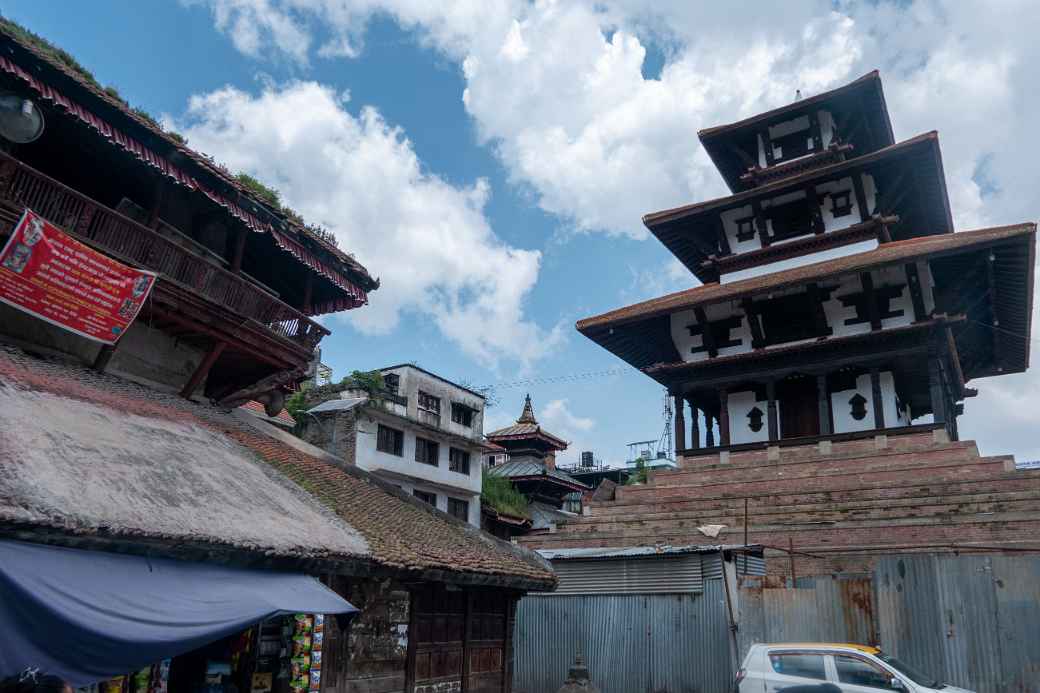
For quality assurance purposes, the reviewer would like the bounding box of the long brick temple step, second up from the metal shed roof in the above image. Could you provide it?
[557,493,1040,534]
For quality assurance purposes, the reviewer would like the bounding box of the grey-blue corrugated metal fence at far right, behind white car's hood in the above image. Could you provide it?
[875,555,1040,693]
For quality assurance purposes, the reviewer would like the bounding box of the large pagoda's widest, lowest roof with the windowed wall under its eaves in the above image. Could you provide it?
[576,223,1036,383]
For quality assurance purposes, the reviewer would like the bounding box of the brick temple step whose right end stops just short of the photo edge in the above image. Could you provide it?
[617,457,1012,503]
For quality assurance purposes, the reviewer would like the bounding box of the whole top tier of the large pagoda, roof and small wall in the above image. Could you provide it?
[698,71,895,193]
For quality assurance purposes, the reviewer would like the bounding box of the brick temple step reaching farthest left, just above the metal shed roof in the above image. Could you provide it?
[521,512,1040,548]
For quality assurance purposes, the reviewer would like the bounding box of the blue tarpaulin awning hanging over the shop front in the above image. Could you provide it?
[0,541,358,686]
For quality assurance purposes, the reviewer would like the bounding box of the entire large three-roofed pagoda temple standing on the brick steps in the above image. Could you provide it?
[577,72,1036,447]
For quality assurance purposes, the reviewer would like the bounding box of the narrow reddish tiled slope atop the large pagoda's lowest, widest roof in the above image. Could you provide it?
[577,223,1036,332]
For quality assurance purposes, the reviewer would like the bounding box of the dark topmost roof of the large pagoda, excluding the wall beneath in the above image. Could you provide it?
[697,70,895,193]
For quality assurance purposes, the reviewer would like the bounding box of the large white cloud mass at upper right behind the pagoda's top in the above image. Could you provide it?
[196,0,1040,455]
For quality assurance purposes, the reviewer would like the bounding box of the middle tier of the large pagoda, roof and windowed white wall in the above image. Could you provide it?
[643,131,954,282]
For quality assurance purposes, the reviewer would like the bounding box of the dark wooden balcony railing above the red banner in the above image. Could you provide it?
[0,152,329,350]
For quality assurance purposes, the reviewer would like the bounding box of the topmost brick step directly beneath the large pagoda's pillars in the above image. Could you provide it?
[679,433,979,470]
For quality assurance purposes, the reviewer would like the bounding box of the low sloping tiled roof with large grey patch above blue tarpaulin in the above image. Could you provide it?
[0,347,554,589]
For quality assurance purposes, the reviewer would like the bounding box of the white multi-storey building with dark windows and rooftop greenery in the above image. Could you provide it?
[300,364,485,527]
